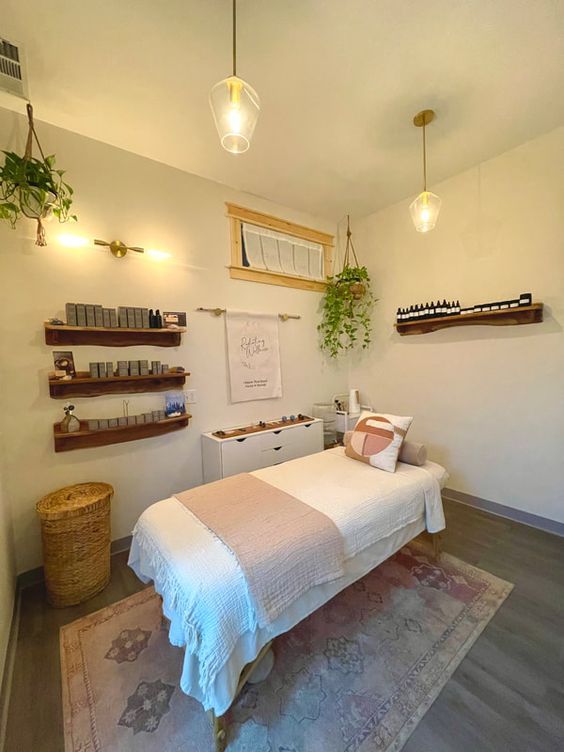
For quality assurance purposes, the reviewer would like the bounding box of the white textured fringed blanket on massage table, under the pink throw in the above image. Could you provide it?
[129,448,446,712]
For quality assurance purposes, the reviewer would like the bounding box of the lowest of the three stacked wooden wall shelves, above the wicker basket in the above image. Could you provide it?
[53,413,192,452]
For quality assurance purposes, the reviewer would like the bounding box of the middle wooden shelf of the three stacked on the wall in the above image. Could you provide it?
[49,371,190,399]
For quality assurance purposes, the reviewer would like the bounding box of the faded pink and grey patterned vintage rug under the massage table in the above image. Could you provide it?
[61,543,512,752]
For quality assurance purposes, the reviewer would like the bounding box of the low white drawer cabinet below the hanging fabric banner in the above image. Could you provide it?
[202,418,323,483]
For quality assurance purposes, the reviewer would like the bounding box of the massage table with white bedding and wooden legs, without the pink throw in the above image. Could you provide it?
[129,447,448,752]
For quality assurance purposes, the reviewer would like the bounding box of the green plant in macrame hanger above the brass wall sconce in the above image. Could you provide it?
[0,104,76,245]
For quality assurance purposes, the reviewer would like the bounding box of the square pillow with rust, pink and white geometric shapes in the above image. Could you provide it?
[345,411,413,473]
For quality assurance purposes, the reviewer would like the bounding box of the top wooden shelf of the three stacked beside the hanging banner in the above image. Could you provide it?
[45,324,186,347]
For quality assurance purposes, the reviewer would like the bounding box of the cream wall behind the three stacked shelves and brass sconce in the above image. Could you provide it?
[0,110,346,572]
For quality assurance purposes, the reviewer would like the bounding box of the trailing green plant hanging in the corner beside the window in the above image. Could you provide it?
[317,216,376,358]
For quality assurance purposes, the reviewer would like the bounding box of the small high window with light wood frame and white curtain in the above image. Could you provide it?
[227,204,333,292]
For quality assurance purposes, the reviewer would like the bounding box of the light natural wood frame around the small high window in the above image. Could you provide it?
[225,202,335,292]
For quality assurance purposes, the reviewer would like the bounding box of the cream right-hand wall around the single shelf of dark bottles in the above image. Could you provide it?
[350,128,564,522]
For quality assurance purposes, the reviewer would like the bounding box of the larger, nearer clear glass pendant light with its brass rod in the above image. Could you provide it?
[210,0,260,154]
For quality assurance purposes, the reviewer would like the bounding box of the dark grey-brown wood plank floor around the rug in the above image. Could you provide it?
[4,500,564,752]
